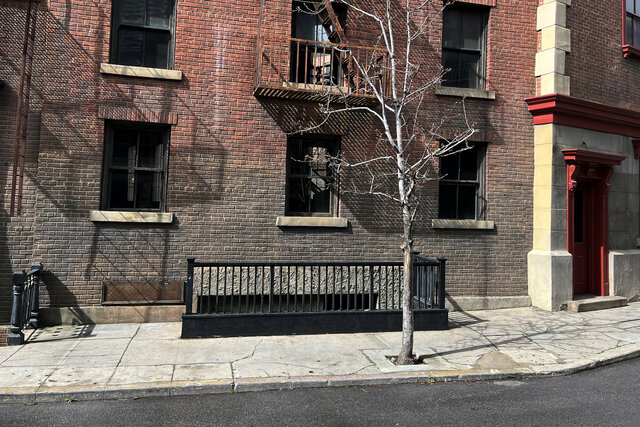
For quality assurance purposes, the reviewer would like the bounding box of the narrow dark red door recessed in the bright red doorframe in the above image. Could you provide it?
[572,189,590,295]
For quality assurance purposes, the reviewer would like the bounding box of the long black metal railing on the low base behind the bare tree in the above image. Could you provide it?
[185,256,446,315]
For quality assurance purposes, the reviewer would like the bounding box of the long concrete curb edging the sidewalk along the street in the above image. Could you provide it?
[0,344,640,403]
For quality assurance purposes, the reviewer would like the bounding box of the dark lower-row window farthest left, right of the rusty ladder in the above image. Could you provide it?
[102,123,169,211]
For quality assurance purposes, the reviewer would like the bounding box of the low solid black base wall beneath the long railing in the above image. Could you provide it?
[182,309,449,338]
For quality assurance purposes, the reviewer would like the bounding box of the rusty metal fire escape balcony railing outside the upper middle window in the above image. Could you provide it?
[253,36,389,106]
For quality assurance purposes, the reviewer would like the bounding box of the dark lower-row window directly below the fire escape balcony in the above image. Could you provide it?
[286,135,339,216]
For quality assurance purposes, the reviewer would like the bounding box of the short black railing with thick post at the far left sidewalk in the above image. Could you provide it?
[7,262,42,345]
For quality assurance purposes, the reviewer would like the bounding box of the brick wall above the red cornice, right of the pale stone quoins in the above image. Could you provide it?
[566,0,640,111]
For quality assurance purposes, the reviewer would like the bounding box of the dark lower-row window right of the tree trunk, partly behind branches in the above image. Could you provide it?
[438,144,485,220]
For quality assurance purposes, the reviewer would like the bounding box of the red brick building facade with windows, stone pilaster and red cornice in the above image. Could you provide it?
[0,0,640,322]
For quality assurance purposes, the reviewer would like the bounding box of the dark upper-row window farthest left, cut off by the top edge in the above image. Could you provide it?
[111,0,176,69]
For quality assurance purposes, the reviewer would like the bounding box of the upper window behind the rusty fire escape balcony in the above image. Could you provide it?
[289,1,347,85]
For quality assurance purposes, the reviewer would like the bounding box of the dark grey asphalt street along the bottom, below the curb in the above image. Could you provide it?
[0,359,640,426]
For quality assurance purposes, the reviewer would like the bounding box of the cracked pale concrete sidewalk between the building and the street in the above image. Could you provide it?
[0,303,640,401]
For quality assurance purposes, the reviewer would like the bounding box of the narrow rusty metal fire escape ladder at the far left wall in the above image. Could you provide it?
[10,0,40,216]
